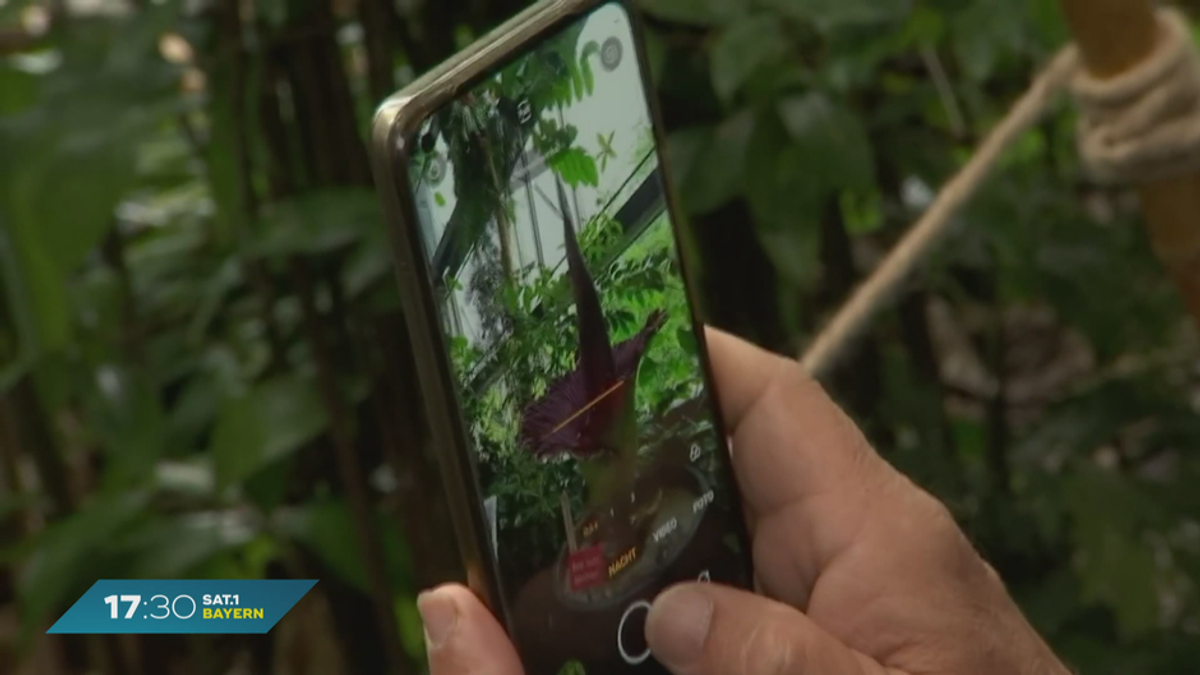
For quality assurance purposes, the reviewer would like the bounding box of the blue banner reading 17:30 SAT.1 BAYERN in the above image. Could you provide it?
[47,579,317,634]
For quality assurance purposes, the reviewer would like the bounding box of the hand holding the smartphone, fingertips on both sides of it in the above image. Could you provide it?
[419,330,1067,675]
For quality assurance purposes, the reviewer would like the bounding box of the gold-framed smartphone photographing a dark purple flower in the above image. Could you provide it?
[372,0,752,675]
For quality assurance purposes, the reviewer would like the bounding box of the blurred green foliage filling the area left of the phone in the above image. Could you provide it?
[0,1,422,674]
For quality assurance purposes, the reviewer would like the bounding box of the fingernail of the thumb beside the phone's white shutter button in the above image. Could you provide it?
[646,585,713,667]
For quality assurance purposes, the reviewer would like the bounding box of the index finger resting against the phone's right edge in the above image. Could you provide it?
[707,329,895,607]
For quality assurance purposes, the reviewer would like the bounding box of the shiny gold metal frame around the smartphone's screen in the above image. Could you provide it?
[370,0,752,629]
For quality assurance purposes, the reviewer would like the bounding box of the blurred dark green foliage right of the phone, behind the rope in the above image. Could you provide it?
[643,0,1200,673]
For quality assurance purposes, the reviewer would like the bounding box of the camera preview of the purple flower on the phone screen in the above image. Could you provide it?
[412,2,734,619]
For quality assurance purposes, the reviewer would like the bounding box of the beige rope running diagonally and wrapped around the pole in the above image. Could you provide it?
[800,8,1200,376]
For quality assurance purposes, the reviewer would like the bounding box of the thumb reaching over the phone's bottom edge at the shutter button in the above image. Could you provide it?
[646,584,887,675]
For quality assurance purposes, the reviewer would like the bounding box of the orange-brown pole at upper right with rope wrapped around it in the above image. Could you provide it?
[1061,0,1200,325]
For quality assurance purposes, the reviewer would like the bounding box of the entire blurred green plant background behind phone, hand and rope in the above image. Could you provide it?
[0,0,1200,675]
